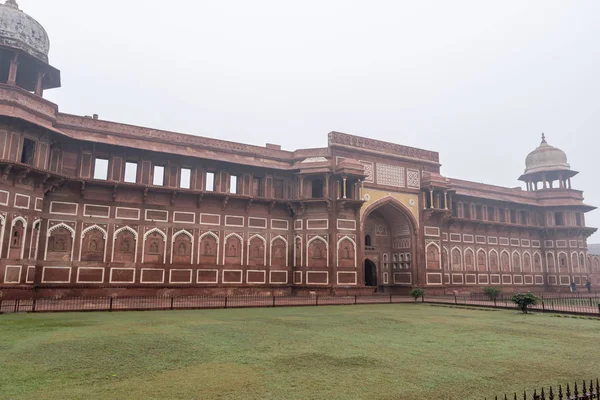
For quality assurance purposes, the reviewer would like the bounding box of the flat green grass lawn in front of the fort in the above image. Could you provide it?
[0,304,600,400]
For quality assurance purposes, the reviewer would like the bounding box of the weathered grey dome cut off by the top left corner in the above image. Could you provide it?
[0,0,50,63]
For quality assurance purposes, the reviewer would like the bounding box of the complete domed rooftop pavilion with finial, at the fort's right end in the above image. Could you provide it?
[519,133,577,190]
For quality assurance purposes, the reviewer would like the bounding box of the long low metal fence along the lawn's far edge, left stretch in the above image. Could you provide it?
[0,295,414,313]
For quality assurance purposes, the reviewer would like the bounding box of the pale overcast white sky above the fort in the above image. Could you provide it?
[18,0,600,242]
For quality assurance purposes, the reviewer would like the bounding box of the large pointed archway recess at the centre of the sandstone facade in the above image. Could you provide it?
[361,196,418,290]
